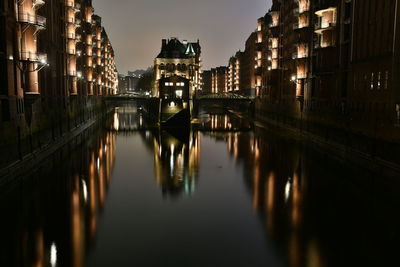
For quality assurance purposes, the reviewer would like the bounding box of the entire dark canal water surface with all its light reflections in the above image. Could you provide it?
[0,106,400,267]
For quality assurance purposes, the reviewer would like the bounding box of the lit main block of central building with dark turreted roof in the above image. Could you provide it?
[153,38,201,96]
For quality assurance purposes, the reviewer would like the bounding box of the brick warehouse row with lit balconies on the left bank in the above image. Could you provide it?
[0,0,118,168]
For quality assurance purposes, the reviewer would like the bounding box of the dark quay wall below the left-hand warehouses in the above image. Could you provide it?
[0,97,112,180]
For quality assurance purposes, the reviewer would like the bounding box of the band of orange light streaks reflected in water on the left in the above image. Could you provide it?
[71,132,116,266]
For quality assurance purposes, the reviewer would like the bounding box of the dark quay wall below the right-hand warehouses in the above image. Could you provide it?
[255,100,400,169]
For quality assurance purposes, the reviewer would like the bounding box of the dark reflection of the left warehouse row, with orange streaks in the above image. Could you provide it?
[0,128,116,267]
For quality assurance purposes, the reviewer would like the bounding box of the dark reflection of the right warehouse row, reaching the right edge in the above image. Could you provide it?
[219,129,400,267]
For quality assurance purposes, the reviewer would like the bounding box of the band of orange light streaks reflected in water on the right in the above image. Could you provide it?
[225,132,325,267]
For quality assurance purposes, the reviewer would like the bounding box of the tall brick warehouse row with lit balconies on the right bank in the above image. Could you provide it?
[206,0,400,165]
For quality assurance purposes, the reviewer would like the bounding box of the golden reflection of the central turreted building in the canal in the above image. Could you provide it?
[153,131,200,199]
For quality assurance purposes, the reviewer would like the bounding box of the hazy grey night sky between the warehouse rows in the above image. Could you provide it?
[93,0,271,74]
